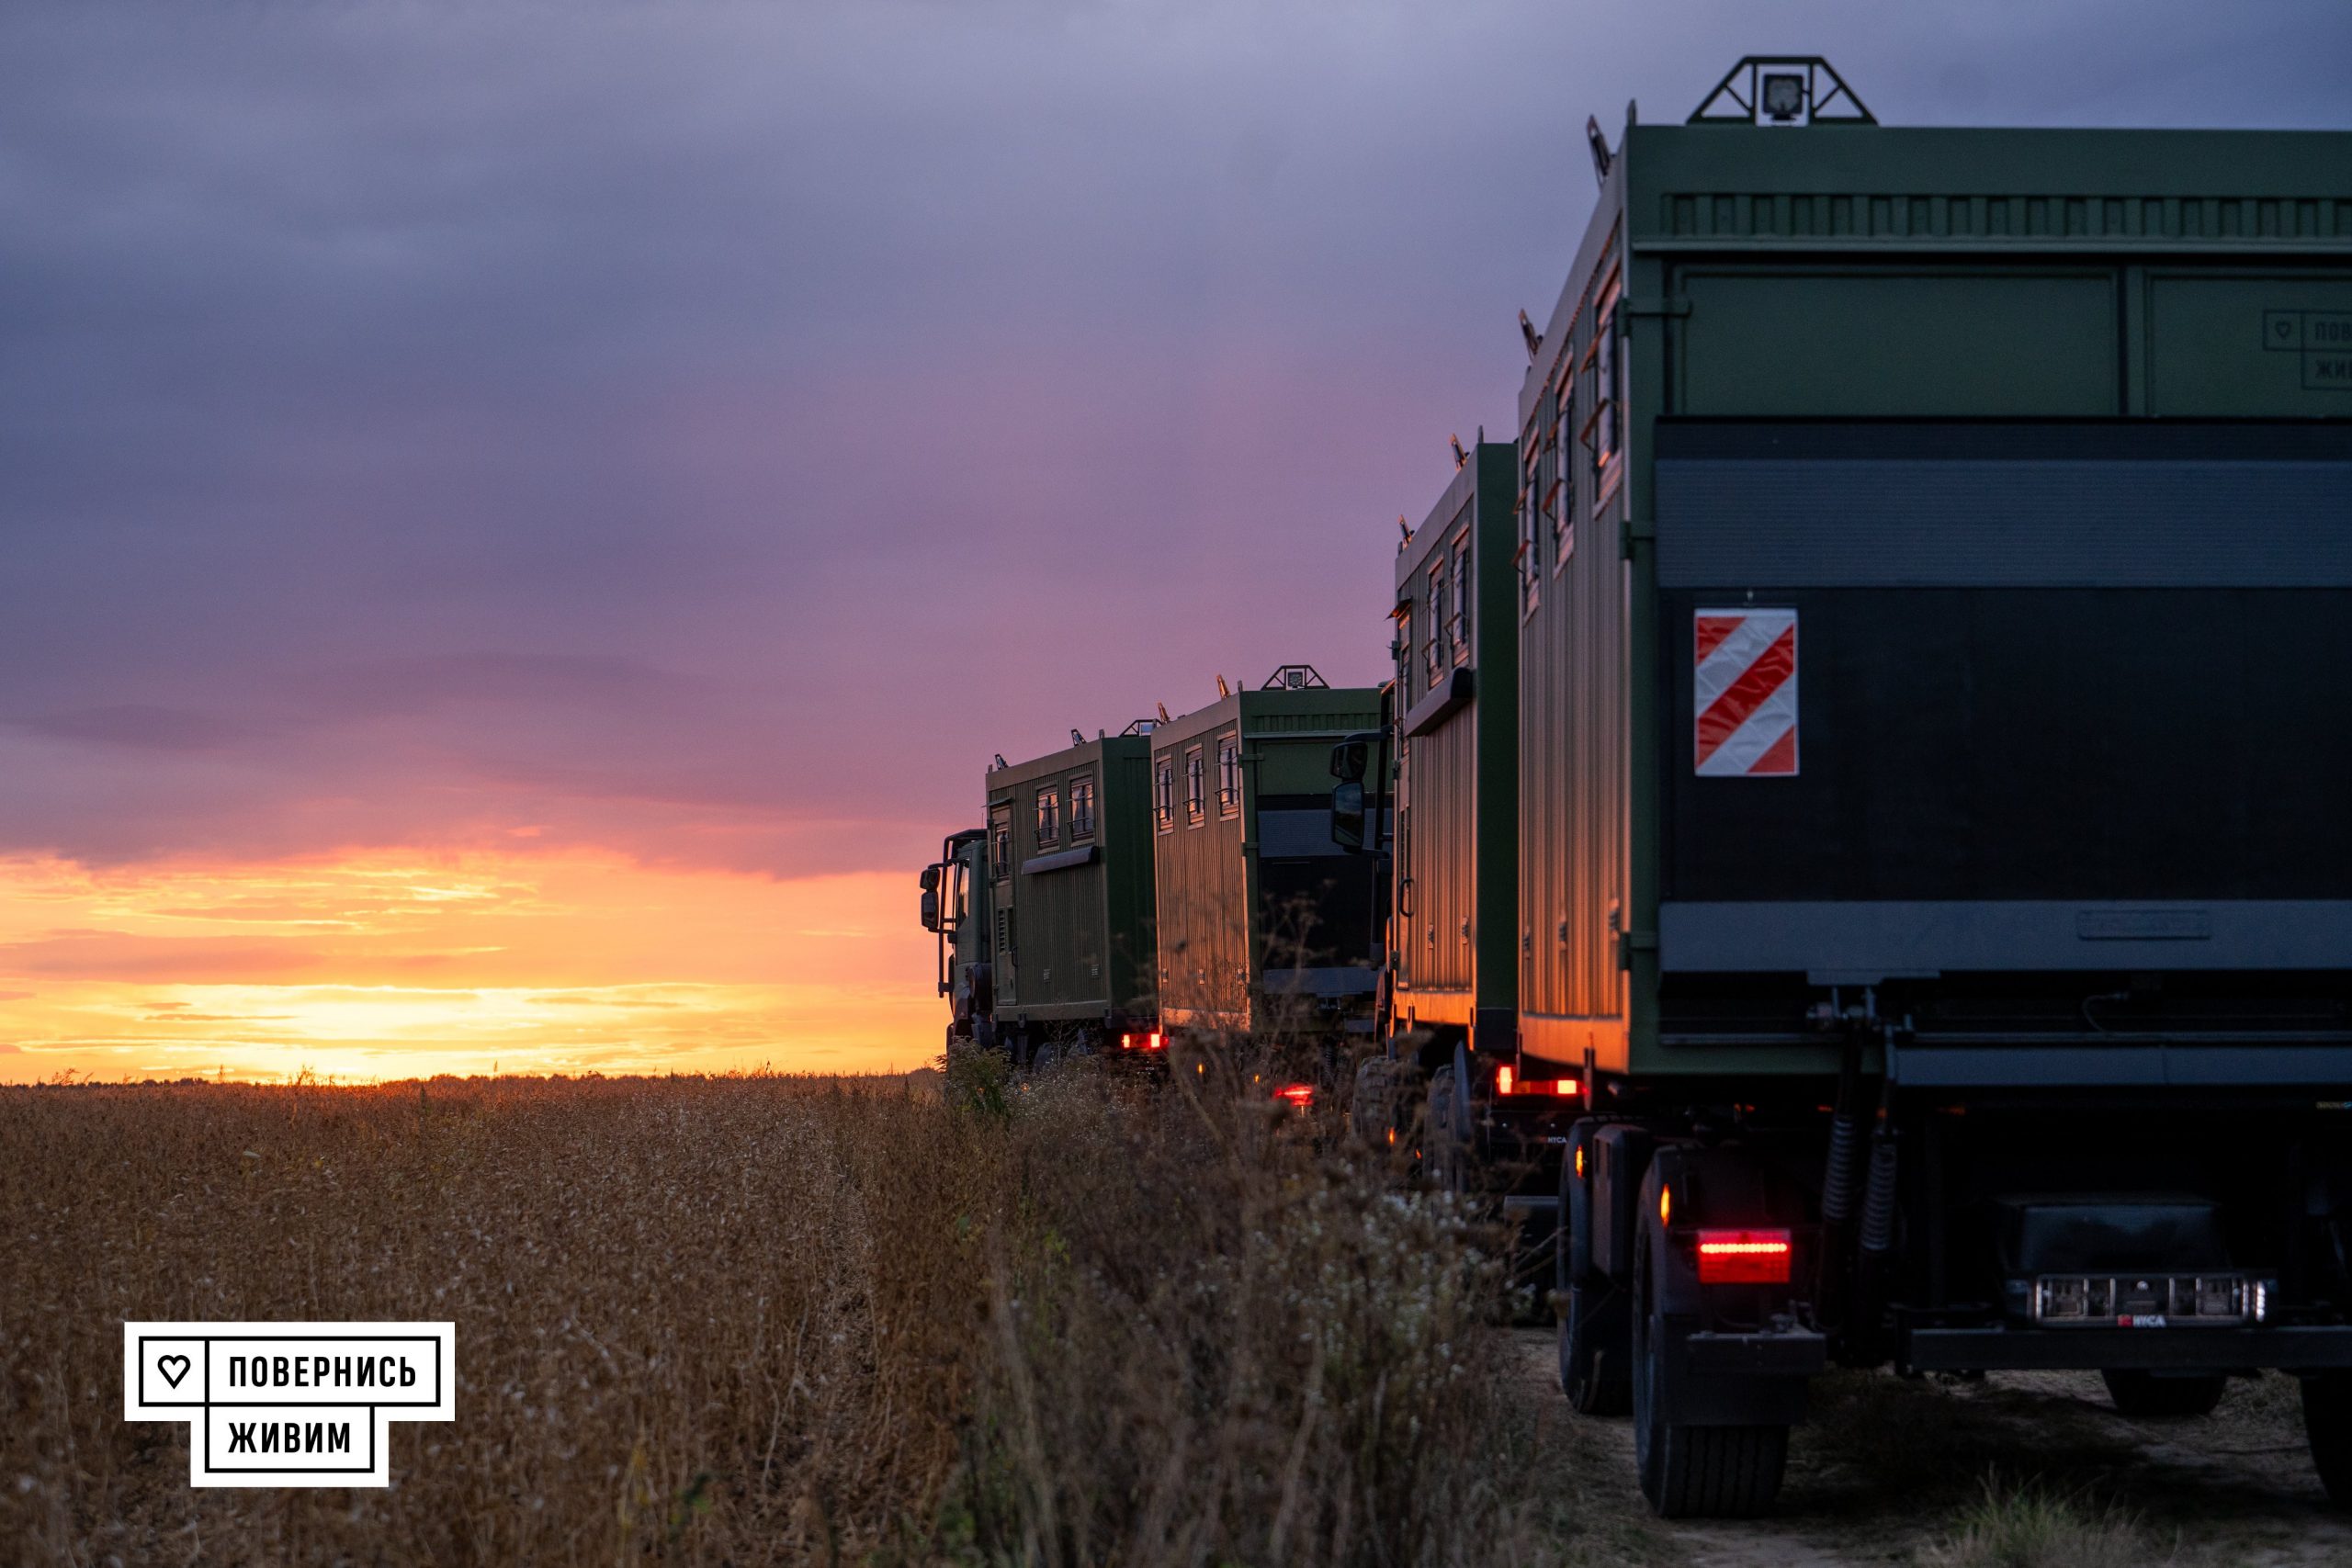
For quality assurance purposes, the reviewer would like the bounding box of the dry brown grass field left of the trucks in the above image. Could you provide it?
[0,1069,1550,1565]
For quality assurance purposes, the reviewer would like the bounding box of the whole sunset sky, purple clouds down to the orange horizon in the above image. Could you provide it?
[0,0,2352,1079]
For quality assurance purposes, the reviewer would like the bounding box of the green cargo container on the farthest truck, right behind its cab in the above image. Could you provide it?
[986,722,1158,1063]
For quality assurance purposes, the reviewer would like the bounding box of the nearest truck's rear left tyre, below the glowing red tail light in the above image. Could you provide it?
[1633,1220,1788,1518]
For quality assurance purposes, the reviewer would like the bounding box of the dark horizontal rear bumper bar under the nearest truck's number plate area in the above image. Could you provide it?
[1895,1325,2352,1373]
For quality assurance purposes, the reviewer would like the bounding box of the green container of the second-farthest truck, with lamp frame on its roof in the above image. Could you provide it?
[1150,665,1381,1037]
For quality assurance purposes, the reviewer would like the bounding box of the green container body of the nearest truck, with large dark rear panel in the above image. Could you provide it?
[1520,110,2352,1077]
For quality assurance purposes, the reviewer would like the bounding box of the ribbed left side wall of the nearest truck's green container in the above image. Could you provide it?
[1520,211,1628,1065]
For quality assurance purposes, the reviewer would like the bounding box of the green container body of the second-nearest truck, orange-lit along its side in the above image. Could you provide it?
[1390,442,1520,1060]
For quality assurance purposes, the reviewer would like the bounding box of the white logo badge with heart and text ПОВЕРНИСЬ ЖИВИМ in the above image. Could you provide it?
[122,1324,457,1485]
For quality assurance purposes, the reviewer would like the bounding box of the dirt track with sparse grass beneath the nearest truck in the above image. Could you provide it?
[1512,1331,2352,1568]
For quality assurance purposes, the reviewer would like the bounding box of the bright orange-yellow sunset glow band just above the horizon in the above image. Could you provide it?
[0,851,945,1081]
